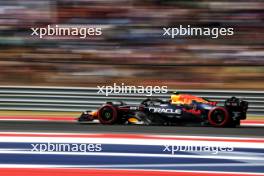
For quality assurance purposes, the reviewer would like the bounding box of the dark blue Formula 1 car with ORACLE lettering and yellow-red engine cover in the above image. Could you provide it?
[78,92,248,127]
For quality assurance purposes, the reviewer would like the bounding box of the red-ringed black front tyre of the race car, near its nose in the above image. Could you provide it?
[98,104,118,125]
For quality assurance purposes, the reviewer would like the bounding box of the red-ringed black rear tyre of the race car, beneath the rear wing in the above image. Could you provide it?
[208,107,230,127]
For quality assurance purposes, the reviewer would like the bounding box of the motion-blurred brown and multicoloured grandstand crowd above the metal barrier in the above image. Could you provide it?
[0,0,264,90]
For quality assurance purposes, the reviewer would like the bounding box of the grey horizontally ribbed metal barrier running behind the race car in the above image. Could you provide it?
[0,86,264,115]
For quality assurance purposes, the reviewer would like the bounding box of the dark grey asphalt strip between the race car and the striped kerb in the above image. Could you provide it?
[0,121,264,137]
